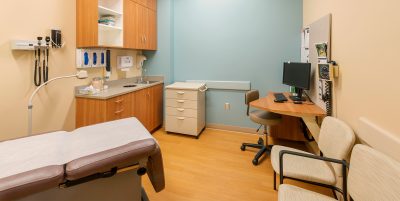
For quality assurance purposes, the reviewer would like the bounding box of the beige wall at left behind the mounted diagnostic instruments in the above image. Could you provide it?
[0,0,140,140]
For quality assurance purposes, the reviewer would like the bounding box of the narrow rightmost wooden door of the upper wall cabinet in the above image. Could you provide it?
[146,9,157,50]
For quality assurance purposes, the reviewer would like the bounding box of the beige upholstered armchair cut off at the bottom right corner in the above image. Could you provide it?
[278,145,400,201]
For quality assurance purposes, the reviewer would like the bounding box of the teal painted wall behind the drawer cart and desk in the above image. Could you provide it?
[148,0,303,127]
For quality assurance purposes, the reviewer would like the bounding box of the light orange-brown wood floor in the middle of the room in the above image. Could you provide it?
[143,129,331,201]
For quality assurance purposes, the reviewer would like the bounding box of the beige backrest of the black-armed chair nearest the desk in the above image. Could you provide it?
[318,117,356,176]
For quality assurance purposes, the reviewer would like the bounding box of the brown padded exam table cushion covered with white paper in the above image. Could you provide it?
[0,118,165,200]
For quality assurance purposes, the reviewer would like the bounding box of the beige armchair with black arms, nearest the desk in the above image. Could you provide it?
[271,117,355,196]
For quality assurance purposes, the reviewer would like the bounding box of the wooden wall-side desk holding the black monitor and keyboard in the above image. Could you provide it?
[250,92,326,141]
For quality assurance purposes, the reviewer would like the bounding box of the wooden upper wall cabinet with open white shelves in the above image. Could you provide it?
[76,0,157,50]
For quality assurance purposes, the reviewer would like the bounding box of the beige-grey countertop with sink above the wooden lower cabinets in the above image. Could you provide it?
[75,76,164,100]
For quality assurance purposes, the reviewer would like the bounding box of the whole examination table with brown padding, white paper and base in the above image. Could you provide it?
[0,118,165,201]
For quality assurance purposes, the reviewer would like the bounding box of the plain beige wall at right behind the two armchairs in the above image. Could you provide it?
[303,0,400,137]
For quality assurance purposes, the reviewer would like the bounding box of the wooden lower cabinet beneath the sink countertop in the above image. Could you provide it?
[76,84,164,132]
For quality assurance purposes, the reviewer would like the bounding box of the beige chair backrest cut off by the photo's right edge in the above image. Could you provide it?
[347,145,400,201]
